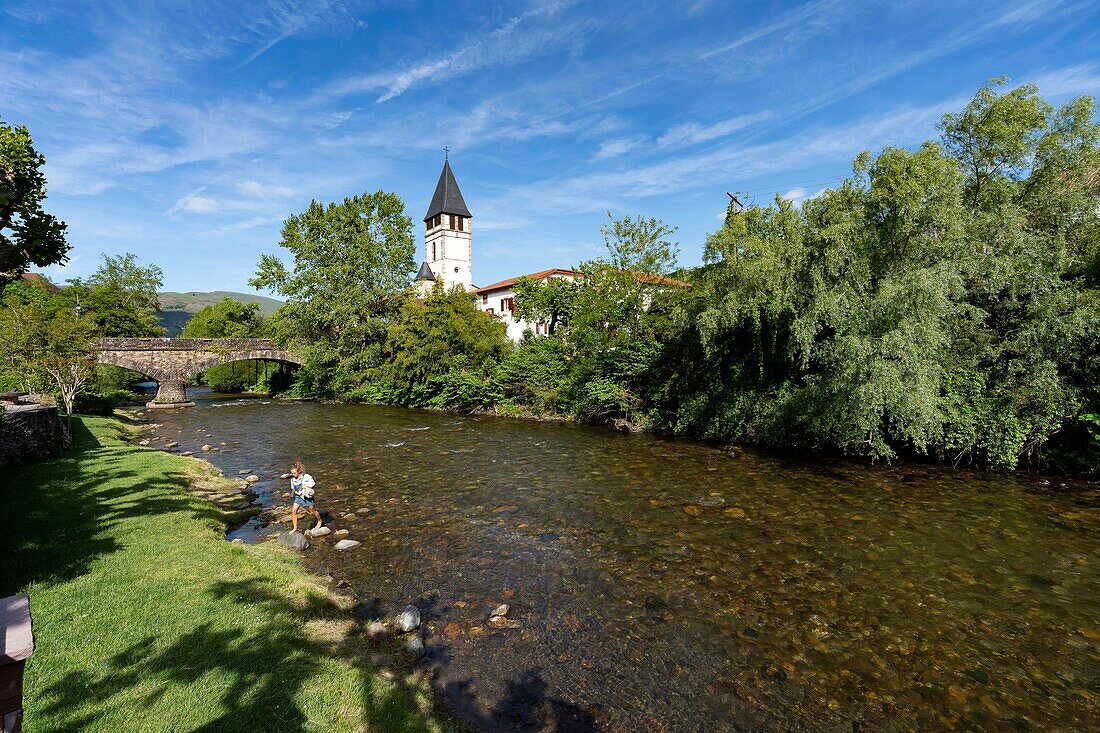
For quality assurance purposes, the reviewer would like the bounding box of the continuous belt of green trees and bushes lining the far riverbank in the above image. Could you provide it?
[243,80,1100,473]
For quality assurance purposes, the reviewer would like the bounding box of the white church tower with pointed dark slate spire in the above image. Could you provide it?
[417,158,473,294]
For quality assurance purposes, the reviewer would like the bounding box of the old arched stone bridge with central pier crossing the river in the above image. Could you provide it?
[92,339,301,406]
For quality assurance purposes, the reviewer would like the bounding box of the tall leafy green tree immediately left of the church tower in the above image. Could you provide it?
[250,190,416,397]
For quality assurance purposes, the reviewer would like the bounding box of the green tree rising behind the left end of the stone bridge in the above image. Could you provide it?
[66,252,165,338]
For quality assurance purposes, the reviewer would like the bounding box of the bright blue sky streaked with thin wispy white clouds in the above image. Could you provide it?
[0,0,1100,291]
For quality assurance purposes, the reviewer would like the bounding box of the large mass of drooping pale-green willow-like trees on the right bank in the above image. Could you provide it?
[659,80,1100,468]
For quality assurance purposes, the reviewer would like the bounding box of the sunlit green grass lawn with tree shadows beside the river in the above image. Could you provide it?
[0,417,451,733]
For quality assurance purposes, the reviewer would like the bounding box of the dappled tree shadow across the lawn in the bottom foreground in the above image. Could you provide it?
[42,578,451,733]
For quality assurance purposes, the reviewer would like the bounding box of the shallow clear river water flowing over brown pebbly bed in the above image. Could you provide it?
[139,395,1100,731]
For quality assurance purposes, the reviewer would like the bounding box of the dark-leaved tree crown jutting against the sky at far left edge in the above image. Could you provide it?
[0,120,69,289]
